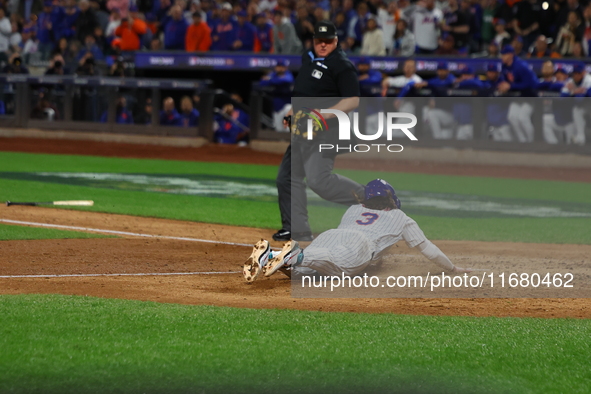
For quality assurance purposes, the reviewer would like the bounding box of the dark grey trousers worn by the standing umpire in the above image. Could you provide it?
[277,139,364,234]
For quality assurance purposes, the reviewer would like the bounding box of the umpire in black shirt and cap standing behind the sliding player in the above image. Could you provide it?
[273,21,364,241]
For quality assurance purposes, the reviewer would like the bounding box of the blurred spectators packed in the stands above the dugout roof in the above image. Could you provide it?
[0,0,591,71]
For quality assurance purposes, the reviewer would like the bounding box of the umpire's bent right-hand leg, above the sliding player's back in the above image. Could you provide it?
[304,151,365,205]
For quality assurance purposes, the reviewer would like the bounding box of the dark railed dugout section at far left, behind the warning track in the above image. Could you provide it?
[0,74,216,140]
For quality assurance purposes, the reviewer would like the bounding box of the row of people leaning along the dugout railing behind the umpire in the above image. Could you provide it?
[260,51,591,145]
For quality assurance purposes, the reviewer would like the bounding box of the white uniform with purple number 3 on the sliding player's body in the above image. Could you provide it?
[296,205,427,275]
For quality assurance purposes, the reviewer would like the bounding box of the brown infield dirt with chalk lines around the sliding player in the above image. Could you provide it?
[0,206,591,318]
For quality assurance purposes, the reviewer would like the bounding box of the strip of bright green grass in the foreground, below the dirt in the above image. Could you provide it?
[0,295,591,393]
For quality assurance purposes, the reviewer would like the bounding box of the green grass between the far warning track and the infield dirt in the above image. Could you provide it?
[0,152,591,244]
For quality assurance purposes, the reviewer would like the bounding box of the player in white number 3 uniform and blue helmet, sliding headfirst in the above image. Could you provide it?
[243,179,470,282]
